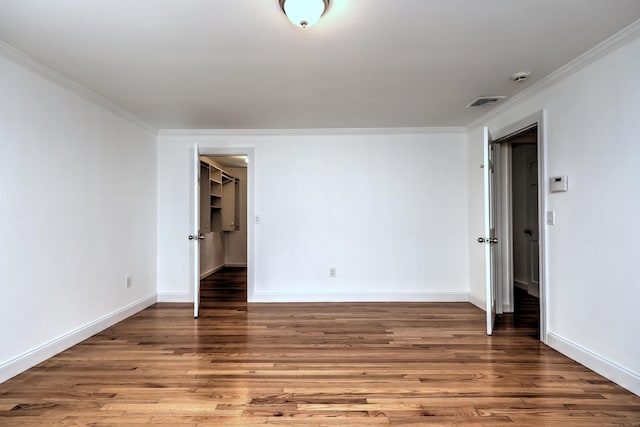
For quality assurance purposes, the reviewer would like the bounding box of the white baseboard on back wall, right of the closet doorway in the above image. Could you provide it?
[251,292,470,302]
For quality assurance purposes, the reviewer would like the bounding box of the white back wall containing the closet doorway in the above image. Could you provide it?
[158,131,469,301]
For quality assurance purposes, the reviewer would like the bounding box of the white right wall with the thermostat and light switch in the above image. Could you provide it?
[469,33,640,393]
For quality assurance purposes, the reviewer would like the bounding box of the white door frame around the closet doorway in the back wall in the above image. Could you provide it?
[189,147,255,304]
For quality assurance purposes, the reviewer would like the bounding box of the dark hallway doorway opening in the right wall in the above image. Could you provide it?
[495,116,547,342]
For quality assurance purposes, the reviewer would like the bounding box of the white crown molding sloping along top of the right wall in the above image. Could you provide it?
[466,19,640,129]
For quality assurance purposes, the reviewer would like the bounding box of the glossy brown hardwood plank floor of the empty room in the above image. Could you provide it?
[0,272,640,426]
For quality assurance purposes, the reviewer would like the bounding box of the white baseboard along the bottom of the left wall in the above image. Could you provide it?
[0,294,156,383]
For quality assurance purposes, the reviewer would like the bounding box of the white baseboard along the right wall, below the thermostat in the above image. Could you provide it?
[547,331,640,395]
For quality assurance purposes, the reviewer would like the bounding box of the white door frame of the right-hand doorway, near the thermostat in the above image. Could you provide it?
[489,109,549,344]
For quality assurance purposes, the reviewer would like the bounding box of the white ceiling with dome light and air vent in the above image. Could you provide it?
[0,0,640,129]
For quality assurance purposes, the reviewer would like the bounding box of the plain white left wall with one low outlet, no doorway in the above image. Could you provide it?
[0,48,156,381]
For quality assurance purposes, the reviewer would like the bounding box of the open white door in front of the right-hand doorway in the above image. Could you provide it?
[478,127,498,335]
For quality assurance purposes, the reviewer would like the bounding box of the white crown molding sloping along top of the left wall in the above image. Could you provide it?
[0,41,158,136]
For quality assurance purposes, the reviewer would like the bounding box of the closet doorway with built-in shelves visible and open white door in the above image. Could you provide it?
[188,147,254,318]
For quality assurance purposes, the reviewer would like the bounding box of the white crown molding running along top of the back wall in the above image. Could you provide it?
[158,126,467,138]
